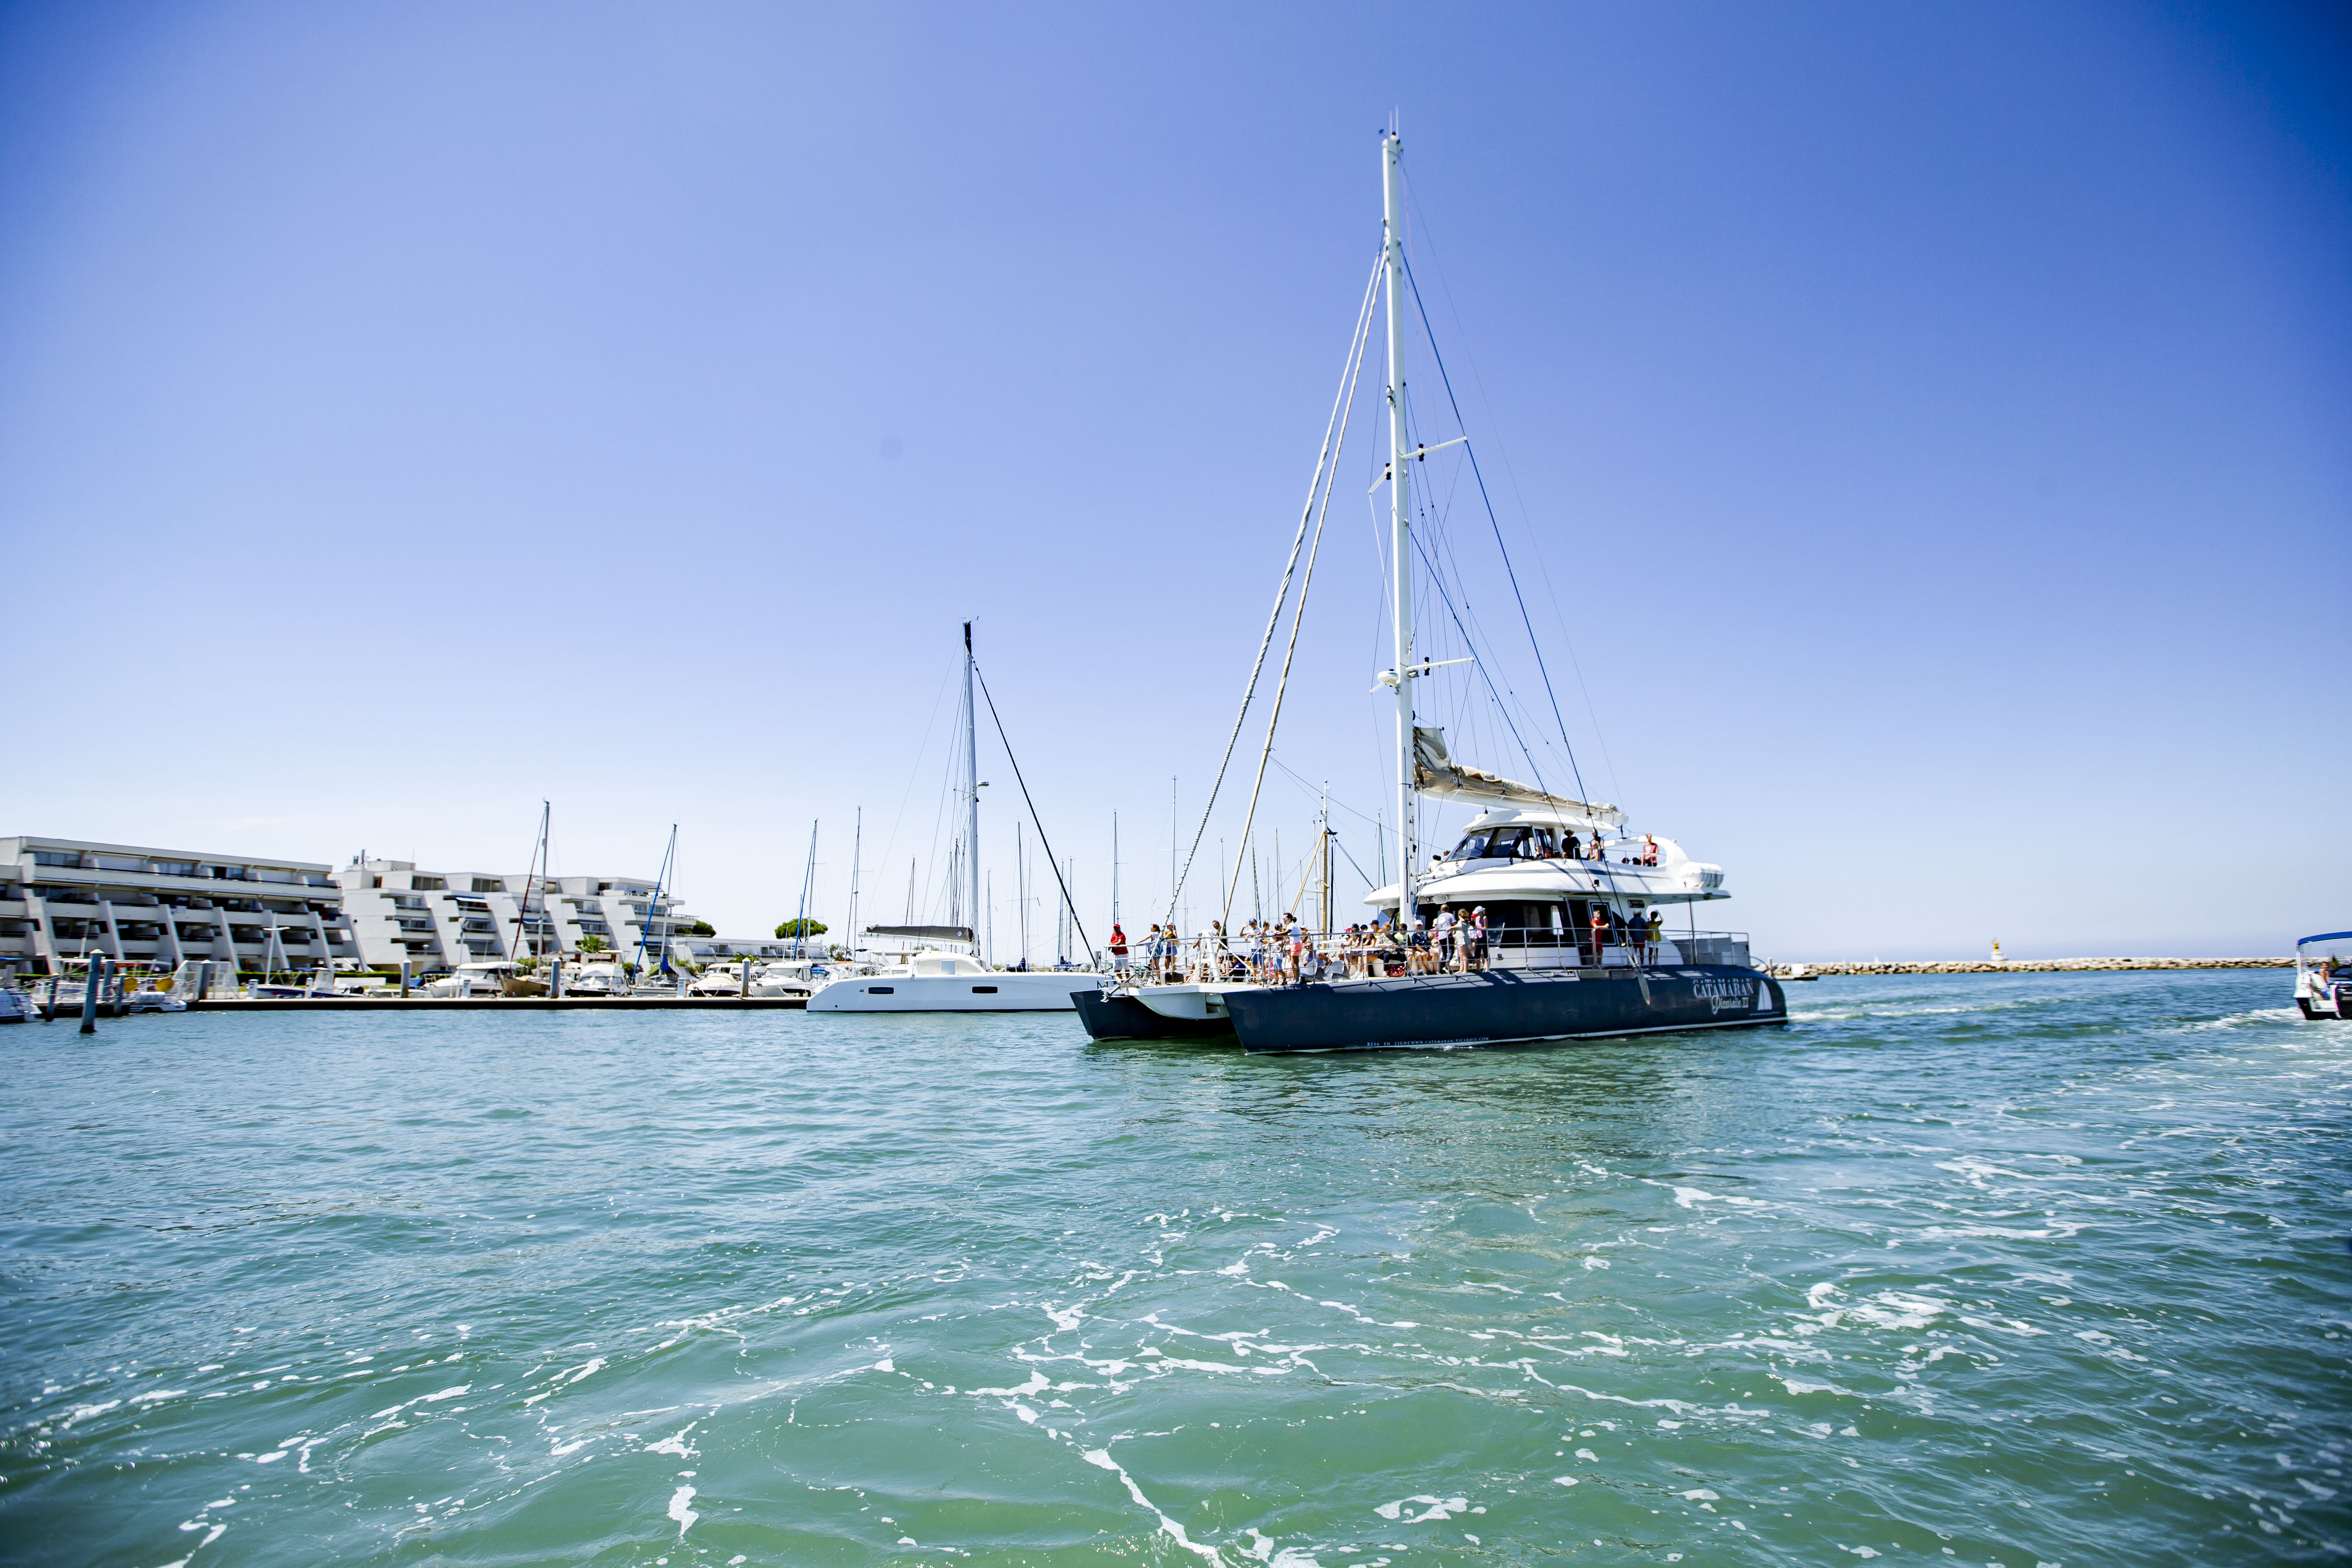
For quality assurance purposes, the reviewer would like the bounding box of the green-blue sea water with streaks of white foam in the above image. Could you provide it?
[0,971,2352,1568]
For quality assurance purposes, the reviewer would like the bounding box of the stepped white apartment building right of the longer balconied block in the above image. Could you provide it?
[334,858,694,973]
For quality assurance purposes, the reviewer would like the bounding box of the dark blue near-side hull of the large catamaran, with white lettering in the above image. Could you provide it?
[1225,966,1788,1051]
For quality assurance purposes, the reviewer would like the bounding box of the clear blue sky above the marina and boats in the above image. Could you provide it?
[0,5,2352,957]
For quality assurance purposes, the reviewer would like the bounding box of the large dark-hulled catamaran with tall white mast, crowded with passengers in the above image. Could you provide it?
[1077,132,1788,1051]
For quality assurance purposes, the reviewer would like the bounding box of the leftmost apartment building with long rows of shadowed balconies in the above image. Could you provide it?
[0,834,358,973]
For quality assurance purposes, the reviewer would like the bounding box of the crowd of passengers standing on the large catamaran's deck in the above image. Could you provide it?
[1110,903,1665,985]
